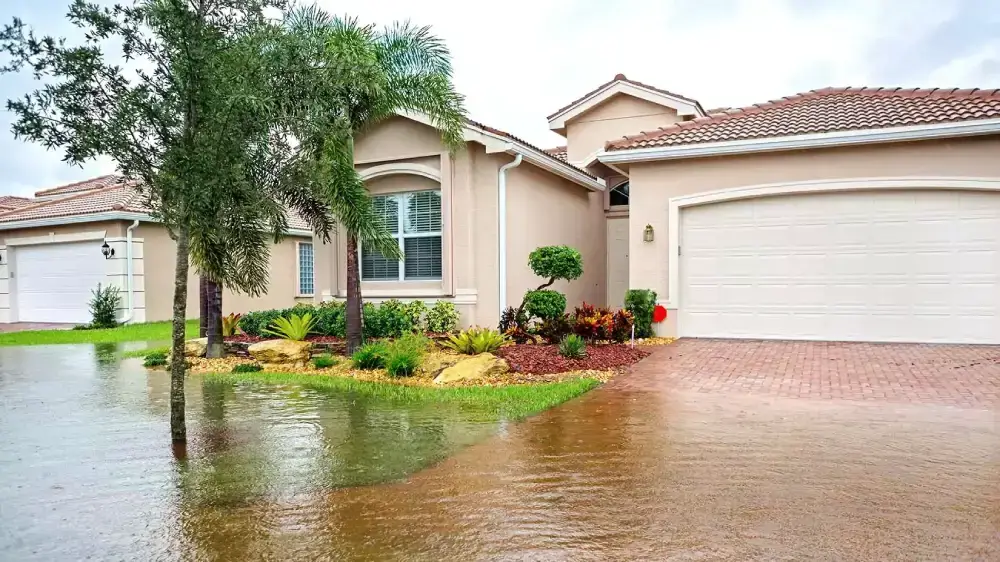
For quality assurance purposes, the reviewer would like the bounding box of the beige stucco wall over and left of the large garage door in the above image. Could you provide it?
[629,137,1000,333]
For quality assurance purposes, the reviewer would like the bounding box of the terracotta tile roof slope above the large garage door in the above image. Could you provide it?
[605,88,1000,150]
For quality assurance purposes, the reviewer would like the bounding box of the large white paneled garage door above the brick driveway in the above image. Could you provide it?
[678,190,1000,343]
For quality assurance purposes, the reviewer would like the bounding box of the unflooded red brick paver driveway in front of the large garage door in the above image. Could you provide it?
[621,339,1000,409]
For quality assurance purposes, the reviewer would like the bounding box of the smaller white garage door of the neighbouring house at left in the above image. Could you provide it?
[14,242,107,323]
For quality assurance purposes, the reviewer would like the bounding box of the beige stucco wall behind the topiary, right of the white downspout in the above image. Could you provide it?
[507,161,607,308]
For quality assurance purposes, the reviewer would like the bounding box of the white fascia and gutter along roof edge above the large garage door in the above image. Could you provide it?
[598,119,1000,164]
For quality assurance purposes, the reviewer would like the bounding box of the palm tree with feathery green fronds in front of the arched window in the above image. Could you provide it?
[287,6,465,352]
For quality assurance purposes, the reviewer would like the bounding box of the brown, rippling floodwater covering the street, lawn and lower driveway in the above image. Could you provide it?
[0,346,1000,561]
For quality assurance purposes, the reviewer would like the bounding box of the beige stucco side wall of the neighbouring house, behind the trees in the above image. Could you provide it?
[134,223,313,321]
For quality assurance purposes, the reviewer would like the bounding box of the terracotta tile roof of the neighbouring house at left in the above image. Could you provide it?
[0,176,312,230]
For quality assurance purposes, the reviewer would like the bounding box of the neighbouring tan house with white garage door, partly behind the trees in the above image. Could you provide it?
[0,176,313,323]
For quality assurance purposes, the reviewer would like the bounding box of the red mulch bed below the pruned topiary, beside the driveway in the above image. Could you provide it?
[497,344,649,375]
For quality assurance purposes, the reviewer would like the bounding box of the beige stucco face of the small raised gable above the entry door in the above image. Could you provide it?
[566,94,681,162]
